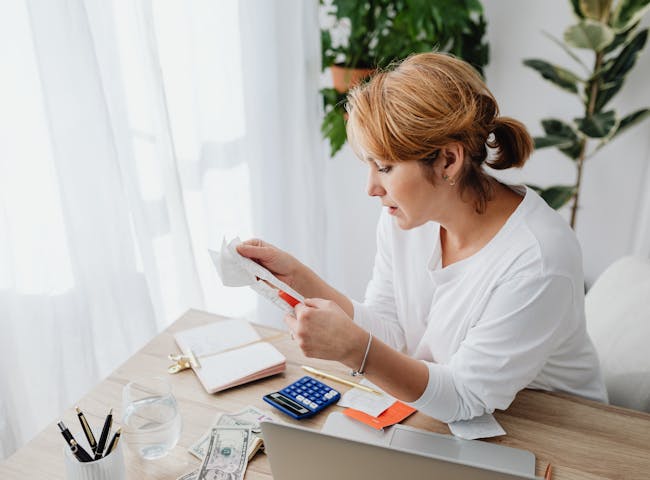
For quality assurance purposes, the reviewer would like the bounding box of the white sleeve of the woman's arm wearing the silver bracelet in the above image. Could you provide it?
[412,275,575,422]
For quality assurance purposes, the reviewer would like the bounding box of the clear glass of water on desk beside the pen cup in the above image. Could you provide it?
[122,377,181,460]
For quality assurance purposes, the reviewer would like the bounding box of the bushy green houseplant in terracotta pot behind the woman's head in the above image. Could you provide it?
[320,0,488,156]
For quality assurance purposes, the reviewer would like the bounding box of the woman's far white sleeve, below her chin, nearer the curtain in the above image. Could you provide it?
[352,212,406,351]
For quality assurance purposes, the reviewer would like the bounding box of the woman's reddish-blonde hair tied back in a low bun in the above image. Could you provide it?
[346,53,533,213]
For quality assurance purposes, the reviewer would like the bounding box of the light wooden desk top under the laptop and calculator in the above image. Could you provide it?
[0,310,650,480]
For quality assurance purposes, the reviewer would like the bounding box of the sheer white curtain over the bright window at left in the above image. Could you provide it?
[0,0,325,458]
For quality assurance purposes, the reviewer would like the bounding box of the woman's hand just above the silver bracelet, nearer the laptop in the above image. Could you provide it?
[284,298,368,364]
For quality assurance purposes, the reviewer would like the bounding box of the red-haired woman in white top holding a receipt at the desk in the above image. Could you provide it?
[238,53,607,422]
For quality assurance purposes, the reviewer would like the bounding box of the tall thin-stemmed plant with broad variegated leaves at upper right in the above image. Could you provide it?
[524,0,650,228]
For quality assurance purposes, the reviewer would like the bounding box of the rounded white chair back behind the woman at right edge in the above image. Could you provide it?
[585,257,650,412]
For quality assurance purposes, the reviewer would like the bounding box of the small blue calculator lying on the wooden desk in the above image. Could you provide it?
[263,376,341,420]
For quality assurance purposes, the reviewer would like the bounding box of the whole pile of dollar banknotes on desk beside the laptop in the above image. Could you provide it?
[178,406,277,480]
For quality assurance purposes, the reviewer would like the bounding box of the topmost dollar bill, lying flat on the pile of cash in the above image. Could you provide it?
[196,427,251,480]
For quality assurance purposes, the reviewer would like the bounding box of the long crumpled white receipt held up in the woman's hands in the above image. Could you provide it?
[208,238,305,313]
